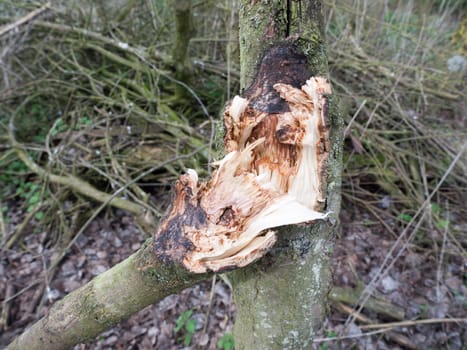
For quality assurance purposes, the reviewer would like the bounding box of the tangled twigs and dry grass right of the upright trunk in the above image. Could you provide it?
[327,1,467,249]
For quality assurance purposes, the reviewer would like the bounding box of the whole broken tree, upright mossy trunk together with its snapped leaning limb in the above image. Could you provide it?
[8,0,342,349]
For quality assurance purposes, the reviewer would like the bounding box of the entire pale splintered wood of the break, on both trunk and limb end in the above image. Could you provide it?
[154,77,331,273]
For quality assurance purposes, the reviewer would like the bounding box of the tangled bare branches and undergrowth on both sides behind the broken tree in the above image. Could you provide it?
[0,0,467,349]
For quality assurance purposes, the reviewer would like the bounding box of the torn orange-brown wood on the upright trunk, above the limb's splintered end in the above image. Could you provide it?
[224,77,331,210]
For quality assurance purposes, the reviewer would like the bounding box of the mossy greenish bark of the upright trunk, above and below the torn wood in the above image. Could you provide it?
[230,0,343,350]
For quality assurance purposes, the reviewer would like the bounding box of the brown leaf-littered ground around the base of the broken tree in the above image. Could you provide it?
[0,200,467,350]
